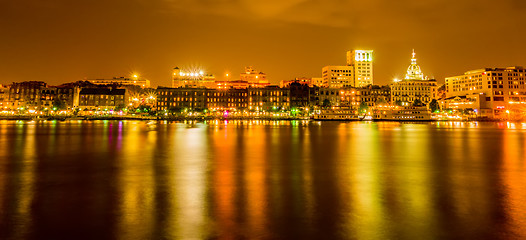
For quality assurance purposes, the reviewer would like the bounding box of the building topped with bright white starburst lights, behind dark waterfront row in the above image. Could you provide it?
[172,67,217,88]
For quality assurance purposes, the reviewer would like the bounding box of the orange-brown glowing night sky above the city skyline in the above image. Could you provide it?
[0,0,526,86]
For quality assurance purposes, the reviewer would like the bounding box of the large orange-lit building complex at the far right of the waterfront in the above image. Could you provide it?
[446,67,526,118]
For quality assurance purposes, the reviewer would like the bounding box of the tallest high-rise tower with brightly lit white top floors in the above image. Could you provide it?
[347,50,373,87]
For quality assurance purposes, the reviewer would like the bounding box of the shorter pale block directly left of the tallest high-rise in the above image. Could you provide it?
[320,66,354,88]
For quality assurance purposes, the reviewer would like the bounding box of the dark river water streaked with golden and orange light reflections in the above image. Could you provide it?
[0,121,526,239]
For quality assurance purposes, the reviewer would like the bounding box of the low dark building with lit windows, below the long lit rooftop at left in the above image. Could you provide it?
[79,88,127,111]
